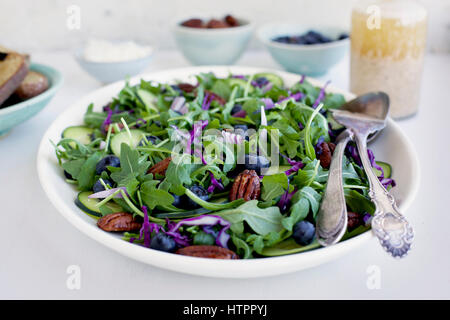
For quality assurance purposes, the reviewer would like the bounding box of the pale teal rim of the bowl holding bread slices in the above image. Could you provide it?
[0,63,64,116]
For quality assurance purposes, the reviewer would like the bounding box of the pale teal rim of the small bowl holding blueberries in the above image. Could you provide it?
[256,22,350,51]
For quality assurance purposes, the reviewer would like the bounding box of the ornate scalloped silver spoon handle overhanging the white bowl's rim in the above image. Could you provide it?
[355,134,414,258]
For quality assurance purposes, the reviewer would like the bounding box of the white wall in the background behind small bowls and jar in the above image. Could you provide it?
[0,0,450,52]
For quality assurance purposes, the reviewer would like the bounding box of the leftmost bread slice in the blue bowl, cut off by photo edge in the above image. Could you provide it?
[0,52,28,105]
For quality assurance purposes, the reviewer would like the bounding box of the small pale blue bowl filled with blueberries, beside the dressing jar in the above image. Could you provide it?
[257,23,350,76]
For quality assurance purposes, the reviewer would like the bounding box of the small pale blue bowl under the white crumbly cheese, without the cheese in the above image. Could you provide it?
[75,48,154,83]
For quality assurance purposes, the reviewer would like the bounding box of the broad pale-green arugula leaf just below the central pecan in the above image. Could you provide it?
[216,200,283,235]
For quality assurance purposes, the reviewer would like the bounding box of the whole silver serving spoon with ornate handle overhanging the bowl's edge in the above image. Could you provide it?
[326,92,414,257]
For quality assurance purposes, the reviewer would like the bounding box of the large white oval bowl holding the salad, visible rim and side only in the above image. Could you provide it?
[37,66,420,278]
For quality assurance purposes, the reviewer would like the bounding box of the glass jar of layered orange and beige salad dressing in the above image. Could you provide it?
[350,0,427,119]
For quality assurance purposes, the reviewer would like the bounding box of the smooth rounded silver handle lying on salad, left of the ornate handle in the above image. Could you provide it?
[316,129,353,246]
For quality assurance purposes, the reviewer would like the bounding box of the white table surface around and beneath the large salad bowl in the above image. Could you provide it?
[0,52,450,299]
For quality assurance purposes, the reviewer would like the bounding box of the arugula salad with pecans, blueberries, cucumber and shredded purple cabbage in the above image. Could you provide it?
[54,73,395,259]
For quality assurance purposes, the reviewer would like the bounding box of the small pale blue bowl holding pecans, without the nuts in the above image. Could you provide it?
[173,19,253,65]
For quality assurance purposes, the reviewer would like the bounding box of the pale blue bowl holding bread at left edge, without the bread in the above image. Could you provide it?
[0,63,63,136]
